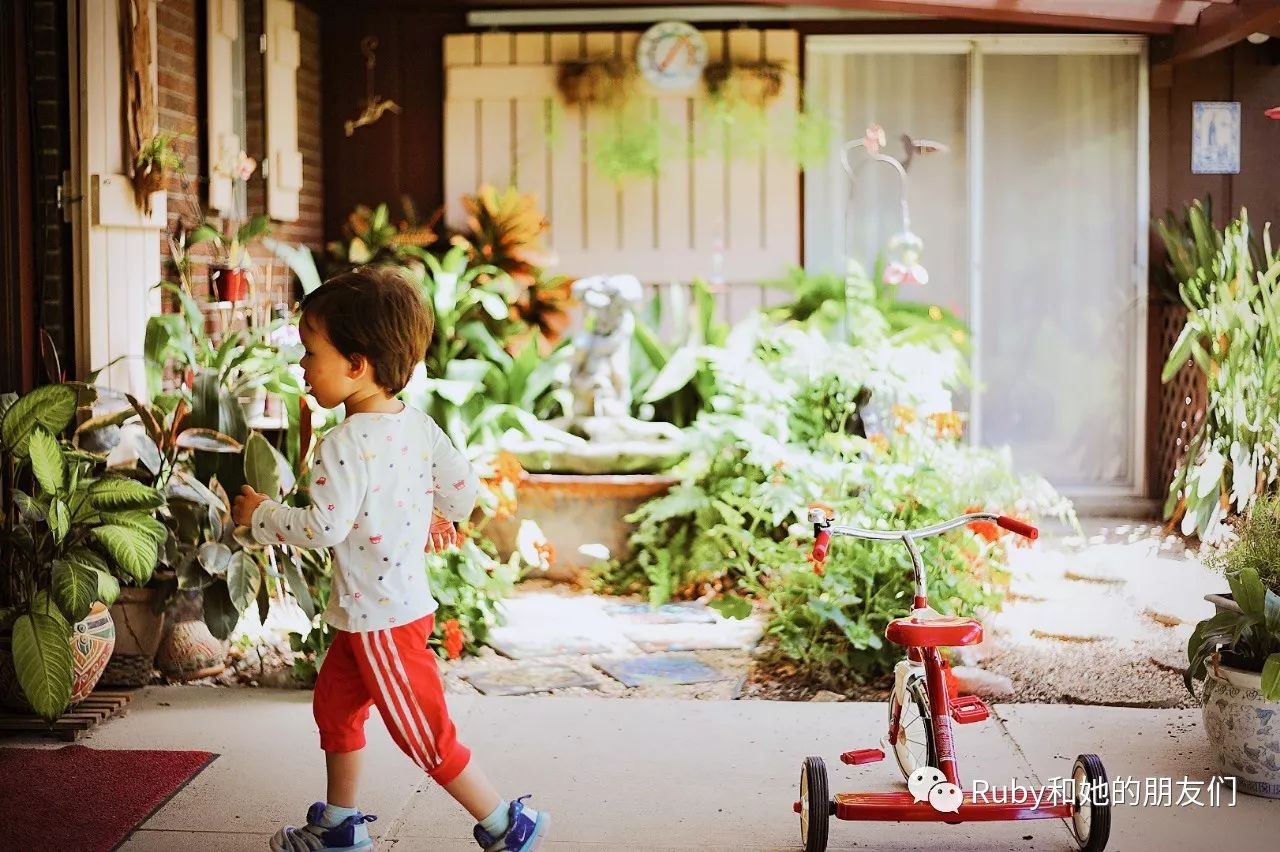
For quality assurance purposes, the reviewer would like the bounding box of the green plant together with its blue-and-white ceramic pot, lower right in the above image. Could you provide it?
[1184,516,1280,798]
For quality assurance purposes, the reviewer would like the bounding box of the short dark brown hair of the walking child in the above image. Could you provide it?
[301,266,435,395]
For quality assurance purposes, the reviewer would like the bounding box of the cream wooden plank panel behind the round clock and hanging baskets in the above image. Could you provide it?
[444,28,800,289]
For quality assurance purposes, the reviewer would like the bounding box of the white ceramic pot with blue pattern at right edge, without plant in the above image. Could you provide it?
[1203,665,1280,798]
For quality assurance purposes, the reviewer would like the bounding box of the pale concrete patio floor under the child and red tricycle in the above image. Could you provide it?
[12,687,1280,852]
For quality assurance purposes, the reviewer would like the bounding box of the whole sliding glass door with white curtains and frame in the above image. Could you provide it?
[805,36,1147,496]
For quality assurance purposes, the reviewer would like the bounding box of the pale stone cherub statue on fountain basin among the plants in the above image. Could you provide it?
[503,275,685,473]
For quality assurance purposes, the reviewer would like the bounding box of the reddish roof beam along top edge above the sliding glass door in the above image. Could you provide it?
[747,0,1208,33]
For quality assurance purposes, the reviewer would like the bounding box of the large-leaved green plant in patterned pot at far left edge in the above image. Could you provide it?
[0,384,165,722]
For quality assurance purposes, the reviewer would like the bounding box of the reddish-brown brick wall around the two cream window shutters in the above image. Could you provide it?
[156,0,324,303]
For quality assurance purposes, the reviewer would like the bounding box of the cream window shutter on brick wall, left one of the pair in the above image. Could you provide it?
[205,0,243,214]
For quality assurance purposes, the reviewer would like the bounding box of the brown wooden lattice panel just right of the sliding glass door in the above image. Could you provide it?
[1153,304,1208,500]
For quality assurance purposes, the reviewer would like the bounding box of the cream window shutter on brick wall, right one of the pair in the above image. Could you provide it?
[264,0,302,221]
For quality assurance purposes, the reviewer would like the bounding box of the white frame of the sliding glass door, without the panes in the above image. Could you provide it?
[804,33,1151,501]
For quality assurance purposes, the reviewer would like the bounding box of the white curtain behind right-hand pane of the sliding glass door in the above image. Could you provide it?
[978,55,1142,490]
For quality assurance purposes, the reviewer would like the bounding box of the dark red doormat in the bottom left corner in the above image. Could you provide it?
[0,746,218,852]
